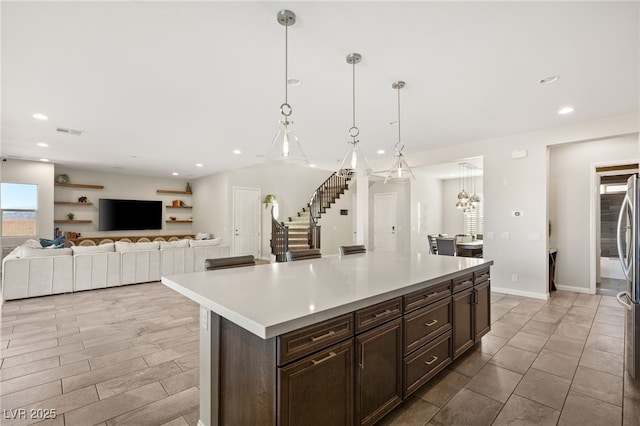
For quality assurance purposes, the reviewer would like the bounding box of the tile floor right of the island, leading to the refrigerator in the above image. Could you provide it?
[382,291,640,426]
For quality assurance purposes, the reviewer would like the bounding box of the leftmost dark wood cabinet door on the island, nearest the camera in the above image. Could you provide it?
[278,339,354,426]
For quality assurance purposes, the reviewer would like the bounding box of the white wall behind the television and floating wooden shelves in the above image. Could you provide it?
[54,166,192,237]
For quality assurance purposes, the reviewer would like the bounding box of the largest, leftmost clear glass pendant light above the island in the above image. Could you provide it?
[264,10,309,165]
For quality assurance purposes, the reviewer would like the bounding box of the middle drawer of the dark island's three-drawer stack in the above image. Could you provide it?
[404,298,452,355]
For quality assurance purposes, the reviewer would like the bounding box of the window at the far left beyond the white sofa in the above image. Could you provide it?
[0,182,38,237]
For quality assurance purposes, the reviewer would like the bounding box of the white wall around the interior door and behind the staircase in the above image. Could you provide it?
[192,165,352,258]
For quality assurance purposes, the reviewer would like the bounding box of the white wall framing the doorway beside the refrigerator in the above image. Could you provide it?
[549,134,638,291]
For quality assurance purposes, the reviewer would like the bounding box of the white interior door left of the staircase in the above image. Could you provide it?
[233,187,262,259]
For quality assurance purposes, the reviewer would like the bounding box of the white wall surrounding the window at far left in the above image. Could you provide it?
[0,159,54,246]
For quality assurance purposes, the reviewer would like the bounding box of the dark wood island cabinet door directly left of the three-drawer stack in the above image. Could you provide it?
[356,318,402,425]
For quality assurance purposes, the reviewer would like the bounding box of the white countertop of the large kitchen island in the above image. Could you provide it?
[162,252,493,339]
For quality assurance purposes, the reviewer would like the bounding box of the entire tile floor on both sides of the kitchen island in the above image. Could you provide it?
[0,283,640,426]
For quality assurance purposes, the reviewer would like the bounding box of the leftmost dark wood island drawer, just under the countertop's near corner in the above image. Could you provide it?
[278,313,353,365]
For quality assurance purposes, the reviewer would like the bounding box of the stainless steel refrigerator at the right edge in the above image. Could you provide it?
[617,175,640,379]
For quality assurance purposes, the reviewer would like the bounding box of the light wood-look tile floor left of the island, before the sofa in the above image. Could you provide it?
[0,283,199,426]
